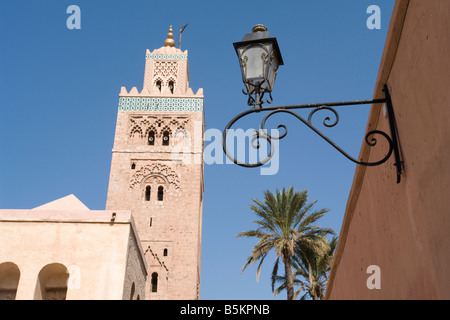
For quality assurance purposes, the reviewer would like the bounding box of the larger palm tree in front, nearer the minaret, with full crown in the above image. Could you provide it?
[237,187,333,300]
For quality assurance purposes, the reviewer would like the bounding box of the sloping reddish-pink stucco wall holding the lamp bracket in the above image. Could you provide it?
[326,0,450,299]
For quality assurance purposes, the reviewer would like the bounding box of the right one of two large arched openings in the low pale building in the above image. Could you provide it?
[34,263,69,300]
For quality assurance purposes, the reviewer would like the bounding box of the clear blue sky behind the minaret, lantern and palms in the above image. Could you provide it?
[0,0,394,300]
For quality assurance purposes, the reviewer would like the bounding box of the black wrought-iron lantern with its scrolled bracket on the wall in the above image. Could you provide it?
[222,24,402,183]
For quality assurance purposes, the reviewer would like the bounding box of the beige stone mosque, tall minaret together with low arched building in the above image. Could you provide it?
[0,28,204,300]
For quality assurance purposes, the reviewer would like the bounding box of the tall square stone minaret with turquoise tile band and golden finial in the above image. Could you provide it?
[106,27,204,300]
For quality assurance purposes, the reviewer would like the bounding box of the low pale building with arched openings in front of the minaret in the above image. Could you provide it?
[0,195,147,300]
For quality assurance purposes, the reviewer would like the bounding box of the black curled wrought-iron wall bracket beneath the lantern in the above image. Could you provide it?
[222,86,402,183]
